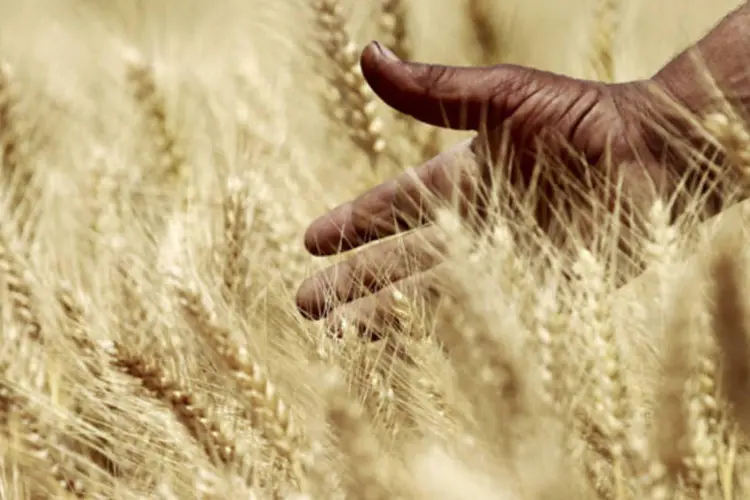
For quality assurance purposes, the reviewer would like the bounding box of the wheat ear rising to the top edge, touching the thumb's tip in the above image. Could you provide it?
[312,0,386,169]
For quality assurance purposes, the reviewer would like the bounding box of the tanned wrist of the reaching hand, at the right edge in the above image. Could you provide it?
[639,2,750,217]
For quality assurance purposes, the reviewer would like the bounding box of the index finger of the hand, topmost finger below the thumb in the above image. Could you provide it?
[305,139,479,256]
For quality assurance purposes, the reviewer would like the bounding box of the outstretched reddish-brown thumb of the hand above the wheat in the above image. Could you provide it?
[360,42,543,130]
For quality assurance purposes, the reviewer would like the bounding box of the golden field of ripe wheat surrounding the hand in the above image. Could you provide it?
[0,0,750,500]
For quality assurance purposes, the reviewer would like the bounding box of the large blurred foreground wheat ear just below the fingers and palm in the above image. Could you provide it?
[438,212,537,464]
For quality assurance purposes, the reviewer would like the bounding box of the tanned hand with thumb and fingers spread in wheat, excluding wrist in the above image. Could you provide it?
[297,43,708,333]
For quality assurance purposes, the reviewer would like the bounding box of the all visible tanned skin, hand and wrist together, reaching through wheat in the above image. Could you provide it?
[297,3,750,333]
